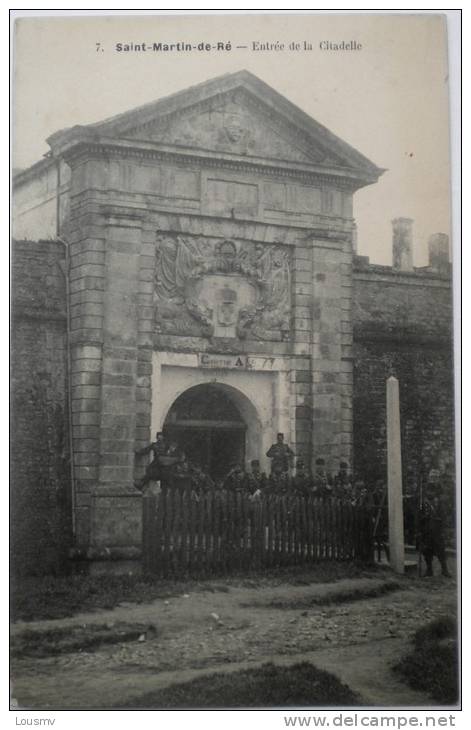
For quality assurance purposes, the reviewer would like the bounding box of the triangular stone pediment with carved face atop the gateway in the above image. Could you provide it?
[48,71,384,184]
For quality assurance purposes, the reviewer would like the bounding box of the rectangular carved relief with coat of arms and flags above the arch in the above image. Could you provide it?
[154,233,291,341]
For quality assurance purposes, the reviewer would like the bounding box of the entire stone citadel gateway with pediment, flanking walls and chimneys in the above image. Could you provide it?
[13,71,453,569]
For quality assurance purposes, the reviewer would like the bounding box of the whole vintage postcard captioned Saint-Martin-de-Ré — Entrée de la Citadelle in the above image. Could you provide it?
[11,11,460,712]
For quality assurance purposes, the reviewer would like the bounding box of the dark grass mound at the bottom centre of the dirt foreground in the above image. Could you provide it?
[119,662,362,709]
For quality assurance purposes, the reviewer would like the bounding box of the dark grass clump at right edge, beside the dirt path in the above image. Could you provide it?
[394,617,459,705]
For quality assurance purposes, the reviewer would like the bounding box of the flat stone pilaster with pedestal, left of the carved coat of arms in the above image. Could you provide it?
[91,214,142,555]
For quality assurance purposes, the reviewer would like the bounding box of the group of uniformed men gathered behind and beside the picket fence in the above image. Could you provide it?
[135,432,449,576]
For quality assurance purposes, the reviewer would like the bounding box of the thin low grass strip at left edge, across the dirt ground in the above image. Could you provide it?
[10,622,157,658]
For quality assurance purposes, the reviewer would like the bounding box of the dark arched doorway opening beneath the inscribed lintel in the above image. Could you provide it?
[163,383,262,479]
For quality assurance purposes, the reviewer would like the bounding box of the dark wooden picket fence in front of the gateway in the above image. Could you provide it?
[143,478,373,577]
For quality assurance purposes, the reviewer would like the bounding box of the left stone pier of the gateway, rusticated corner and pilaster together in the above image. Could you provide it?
[67,200,150,557]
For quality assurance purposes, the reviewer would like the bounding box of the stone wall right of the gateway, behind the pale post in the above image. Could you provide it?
[353,257,454,483]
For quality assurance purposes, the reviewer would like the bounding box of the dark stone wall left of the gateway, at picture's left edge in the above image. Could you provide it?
[11,241,72,575]
